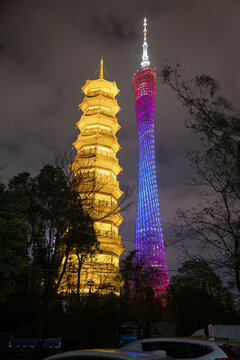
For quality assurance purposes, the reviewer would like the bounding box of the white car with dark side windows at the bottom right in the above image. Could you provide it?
[121,337,233,360]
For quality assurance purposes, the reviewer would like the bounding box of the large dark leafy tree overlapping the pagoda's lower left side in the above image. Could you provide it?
[4,165,97,338]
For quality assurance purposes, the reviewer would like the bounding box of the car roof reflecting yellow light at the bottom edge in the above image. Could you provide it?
[45,349,170,360]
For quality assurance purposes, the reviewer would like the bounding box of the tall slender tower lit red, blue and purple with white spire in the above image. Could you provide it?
[134,18,169,296]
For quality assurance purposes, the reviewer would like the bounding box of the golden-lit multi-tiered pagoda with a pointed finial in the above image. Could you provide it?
[61,59,124,293]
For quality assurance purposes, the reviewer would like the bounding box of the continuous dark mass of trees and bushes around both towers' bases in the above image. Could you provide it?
[0,180,239,348]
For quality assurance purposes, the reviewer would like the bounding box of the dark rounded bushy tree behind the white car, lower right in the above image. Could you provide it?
[167,259,238,336]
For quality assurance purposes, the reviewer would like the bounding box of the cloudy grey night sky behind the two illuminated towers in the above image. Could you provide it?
[0,0,240,270]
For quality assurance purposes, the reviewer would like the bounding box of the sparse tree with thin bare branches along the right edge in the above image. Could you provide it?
[161,65,240,292]
